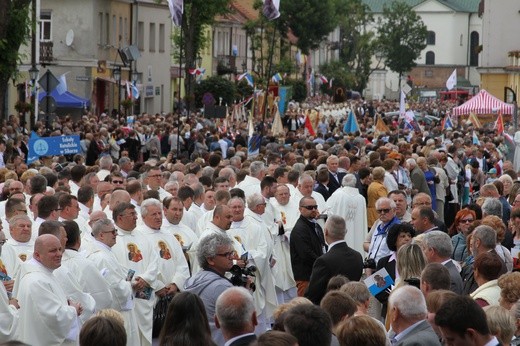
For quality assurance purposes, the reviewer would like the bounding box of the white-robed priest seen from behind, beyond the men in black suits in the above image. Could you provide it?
[327,174,368,253]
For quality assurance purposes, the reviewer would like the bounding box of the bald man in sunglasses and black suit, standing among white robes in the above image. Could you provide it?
[290,197,327,297]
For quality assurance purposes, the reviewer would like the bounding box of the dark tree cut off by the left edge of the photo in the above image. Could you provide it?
[0,0,31,119]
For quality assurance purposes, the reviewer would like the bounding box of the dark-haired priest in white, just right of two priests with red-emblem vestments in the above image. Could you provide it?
[161,197,200,273]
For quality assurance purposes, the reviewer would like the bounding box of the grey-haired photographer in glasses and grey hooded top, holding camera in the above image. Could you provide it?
[184,233,234,345]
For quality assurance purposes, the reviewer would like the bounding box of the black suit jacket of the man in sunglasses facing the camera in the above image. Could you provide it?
[290,216,325,281]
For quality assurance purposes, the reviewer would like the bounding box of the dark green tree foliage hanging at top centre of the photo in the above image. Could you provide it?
[276,0,345,54]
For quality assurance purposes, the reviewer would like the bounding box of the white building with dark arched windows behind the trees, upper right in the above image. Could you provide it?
[363,0,482,99]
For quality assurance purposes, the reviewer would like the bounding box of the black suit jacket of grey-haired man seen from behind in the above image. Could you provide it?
[305,242,363,305]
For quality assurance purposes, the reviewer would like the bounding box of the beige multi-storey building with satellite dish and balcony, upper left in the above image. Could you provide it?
[10,0,171,119]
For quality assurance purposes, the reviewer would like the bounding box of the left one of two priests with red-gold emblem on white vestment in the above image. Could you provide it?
[112,203,158,346]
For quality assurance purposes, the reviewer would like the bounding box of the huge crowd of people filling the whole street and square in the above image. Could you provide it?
[0,93,520,346]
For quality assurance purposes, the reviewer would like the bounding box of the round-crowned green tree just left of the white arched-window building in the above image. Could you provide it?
[378,1,428,80]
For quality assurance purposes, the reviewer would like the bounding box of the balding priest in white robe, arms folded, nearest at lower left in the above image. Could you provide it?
[16,234,82,346]
